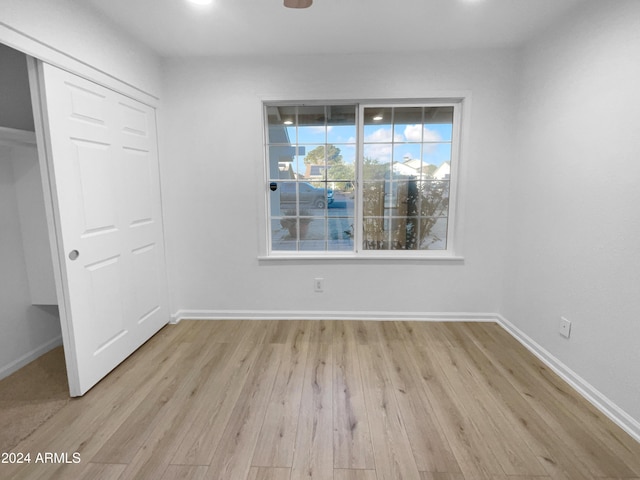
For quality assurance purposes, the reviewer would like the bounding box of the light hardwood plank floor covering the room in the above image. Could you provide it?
[0,321,640,480]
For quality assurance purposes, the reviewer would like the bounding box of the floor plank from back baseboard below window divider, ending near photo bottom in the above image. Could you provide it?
[333,321,375,469]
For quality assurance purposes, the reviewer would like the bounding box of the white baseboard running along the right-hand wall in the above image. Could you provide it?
[496,315,640,442]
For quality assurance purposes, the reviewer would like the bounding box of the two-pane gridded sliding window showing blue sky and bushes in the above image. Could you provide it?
[265,102,460,257]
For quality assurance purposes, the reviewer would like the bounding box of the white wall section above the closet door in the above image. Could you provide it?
[0,0,161,97]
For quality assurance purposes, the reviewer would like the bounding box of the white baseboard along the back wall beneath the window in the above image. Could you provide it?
[171,310,497,324]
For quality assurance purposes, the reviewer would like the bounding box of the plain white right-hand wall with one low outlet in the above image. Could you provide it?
[501,0,640,426]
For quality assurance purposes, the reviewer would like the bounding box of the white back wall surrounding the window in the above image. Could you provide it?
[160,51,515,313]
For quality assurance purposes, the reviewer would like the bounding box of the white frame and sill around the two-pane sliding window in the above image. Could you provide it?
[259,95,470,261]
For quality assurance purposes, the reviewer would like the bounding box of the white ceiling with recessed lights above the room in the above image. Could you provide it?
[82,0,585,57]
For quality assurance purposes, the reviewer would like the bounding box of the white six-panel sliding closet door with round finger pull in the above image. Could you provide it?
[39,64,169,396]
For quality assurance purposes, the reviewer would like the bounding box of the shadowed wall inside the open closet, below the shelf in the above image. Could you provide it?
[0,144,61,378]
